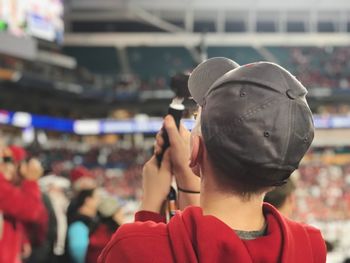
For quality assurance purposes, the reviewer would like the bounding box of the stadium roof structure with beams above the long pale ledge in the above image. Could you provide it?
[66,0,350,33]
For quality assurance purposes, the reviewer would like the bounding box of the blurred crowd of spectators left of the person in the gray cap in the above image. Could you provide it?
[0,143,145,263]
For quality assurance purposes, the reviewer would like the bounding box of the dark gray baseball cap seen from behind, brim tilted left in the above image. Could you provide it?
[189,59,314,186]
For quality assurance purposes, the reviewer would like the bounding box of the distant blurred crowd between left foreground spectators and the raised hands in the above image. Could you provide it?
[28,147,149,200]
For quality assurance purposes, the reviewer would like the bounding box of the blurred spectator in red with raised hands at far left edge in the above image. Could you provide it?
[0,148,46,263]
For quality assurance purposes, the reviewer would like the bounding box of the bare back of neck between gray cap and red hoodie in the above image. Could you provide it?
[200,177,265,231]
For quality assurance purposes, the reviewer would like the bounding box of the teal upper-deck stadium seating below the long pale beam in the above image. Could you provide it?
[59,46,350,90]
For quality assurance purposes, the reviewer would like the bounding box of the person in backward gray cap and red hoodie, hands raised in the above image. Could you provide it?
[99,58,326,263]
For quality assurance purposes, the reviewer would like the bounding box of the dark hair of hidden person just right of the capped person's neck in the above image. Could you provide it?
[264,178,296,209]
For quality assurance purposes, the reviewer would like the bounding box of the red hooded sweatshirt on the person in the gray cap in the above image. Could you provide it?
[99,204,326,263]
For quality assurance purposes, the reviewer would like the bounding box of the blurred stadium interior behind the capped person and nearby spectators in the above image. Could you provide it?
[0,0,350,262]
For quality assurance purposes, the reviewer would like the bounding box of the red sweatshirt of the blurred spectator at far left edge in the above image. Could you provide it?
[0,174,47,263]
